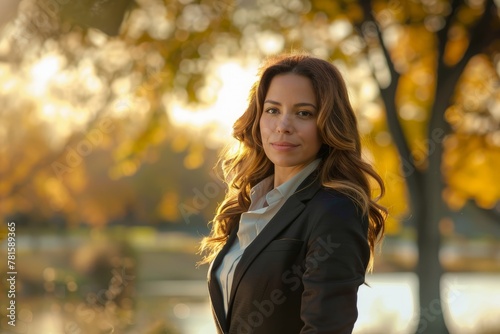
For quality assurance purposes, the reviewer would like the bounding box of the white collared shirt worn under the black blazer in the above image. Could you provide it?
[215,159,321,313]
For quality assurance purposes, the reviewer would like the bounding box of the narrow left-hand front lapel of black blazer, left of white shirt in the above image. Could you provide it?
[207,224,239,333]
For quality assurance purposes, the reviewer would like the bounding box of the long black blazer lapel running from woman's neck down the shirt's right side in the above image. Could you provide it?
[228,172,320,318]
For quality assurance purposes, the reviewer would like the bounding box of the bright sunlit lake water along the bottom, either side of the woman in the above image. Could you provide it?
[5,273,500,334]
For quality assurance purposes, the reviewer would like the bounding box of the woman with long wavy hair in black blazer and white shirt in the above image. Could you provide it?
[201,55,386,334]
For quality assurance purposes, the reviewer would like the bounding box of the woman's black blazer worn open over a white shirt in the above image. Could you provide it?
[208,173,370,334]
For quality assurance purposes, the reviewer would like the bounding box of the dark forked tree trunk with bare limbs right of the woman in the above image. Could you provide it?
[350,0,499,334]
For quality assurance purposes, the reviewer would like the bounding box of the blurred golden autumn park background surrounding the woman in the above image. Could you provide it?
[0,0,500,334]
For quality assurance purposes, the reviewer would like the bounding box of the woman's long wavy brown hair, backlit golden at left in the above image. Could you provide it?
[200,54,387,269]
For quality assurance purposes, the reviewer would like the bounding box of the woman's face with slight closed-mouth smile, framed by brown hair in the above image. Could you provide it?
[260,73,322,176]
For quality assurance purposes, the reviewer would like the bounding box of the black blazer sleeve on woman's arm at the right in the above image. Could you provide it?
[301,192,370,334]
